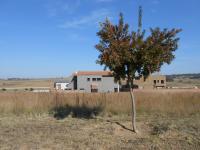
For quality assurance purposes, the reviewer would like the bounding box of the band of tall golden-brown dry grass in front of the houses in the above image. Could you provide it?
[0,90,200,115]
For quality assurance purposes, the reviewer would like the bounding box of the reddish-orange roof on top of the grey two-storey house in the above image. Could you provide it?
[74,71,112,76]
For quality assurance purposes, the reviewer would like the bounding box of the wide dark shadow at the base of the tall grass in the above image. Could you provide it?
[51,105,103,119]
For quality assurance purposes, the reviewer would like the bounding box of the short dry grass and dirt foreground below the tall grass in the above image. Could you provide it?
[0,114,200,150]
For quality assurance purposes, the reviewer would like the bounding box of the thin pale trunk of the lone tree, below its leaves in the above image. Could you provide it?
[129,82,137,133]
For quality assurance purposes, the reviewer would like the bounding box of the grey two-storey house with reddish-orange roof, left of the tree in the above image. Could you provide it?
[72,71,119,93]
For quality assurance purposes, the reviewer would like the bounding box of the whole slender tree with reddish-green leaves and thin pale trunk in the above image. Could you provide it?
[95,7,181,132]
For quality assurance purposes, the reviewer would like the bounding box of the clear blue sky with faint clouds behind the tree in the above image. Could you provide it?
[0,0,200,78]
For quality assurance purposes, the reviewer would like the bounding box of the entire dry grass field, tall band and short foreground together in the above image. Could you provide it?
[0,90,200,149]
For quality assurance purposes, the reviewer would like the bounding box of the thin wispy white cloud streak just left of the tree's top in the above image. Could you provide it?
[59,9,111,29]
